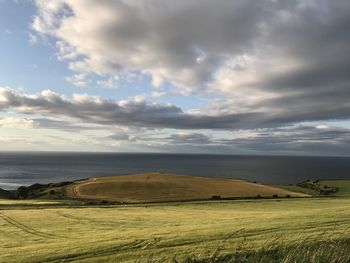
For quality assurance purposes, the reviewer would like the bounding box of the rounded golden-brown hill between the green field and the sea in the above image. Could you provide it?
[62,173,307,203]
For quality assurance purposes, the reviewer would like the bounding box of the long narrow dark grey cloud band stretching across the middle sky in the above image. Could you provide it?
[0,88,349,130]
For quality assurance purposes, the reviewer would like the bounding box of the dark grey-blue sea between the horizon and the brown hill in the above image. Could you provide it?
[0,152,350,189]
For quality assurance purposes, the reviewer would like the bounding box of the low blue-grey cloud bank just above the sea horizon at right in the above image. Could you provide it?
[220,126,350,156]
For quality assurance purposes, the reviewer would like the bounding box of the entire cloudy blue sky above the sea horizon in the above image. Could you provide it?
[0,0,350,156]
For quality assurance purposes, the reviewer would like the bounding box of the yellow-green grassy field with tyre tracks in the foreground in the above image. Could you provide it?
[0,198,350,262]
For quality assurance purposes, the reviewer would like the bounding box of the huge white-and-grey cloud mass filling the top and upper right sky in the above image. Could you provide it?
[33,0,350,116]
